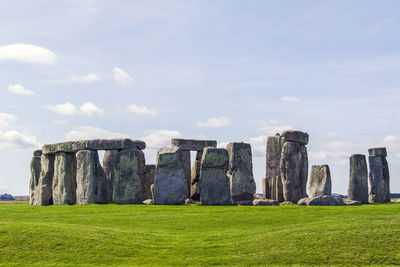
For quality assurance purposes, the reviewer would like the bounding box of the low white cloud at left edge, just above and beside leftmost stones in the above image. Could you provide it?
[0,130,41,149]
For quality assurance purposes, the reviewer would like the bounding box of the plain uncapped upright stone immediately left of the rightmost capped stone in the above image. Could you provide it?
[347,154,368,203]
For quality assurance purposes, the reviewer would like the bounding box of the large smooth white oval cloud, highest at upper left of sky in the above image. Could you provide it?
[0,44,56,65]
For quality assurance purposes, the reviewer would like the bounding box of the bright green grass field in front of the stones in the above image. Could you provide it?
[0,203,400,266]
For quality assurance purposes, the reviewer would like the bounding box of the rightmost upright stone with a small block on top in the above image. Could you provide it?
[368,147,390,203]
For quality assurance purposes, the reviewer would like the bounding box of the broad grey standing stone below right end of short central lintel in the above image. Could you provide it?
[198,147,232,205]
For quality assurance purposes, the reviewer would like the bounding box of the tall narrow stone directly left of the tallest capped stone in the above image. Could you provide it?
[265,134,283,200]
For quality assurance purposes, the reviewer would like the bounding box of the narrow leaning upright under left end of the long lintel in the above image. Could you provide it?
[33,154,54,206]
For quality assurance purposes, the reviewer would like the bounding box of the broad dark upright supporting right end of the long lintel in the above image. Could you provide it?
[112,148,146,204]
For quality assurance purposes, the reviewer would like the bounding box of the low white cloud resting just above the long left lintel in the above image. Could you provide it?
[65,126,129,140]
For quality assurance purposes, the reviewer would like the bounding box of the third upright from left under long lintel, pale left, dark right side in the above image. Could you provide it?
[76,150,108,204]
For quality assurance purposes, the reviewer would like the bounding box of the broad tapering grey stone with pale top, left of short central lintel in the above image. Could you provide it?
[154,147,188,205]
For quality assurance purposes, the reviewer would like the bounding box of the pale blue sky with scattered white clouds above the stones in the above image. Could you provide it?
[0,0,400,195]
